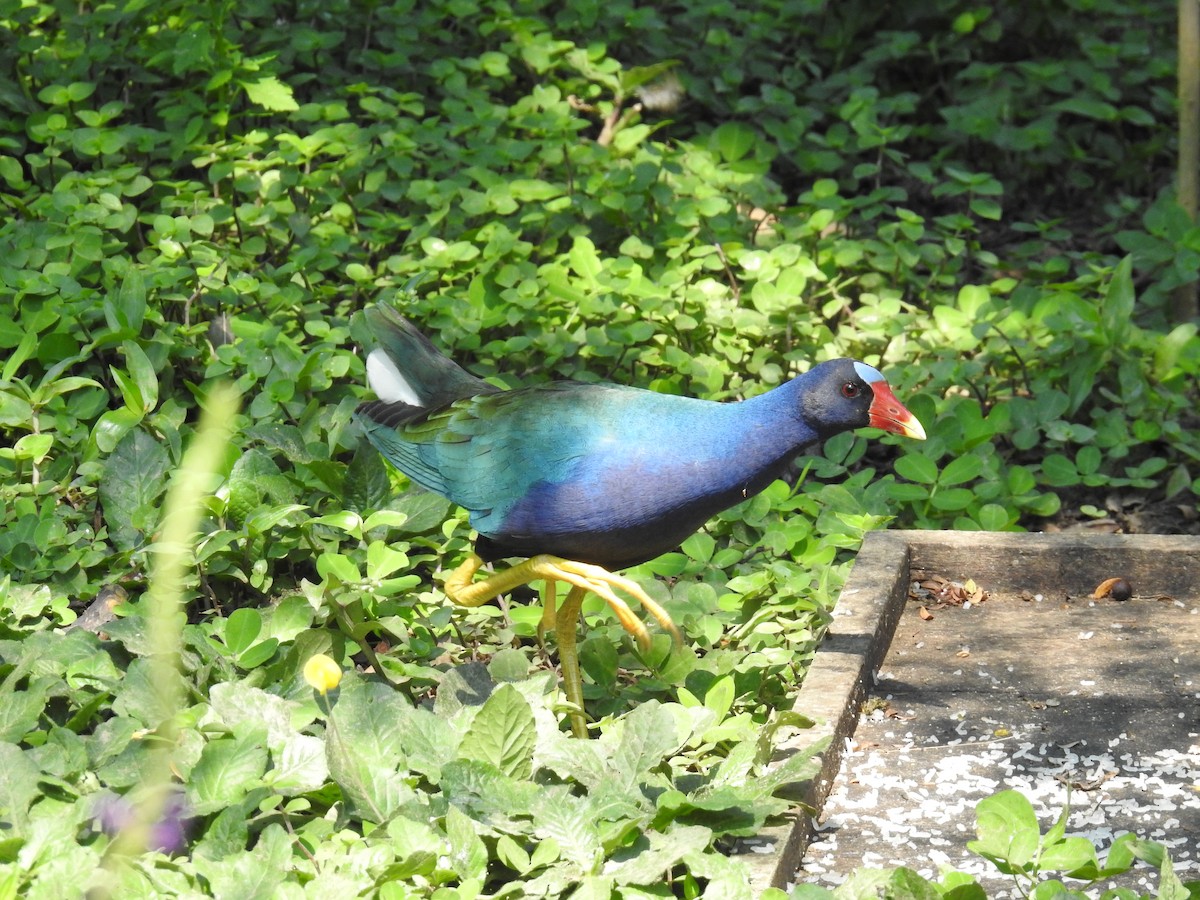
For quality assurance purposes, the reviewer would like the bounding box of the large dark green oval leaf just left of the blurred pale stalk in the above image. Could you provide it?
[100,428,170,550]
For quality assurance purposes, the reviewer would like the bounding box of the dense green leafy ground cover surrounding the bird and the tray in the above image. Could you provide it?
[0,0,1200,898]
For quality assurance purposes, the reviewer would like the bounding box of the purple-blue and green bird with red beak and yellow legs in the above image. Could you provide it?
[354,304,925,737]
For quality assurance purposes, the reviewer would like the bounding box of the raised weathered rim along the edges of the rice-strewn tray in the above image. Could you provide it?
[734,530,1200,893]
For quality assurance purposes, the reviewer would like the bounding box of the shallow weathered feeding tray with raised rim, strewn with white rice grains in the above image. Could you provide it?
[740,532,1200,895]
